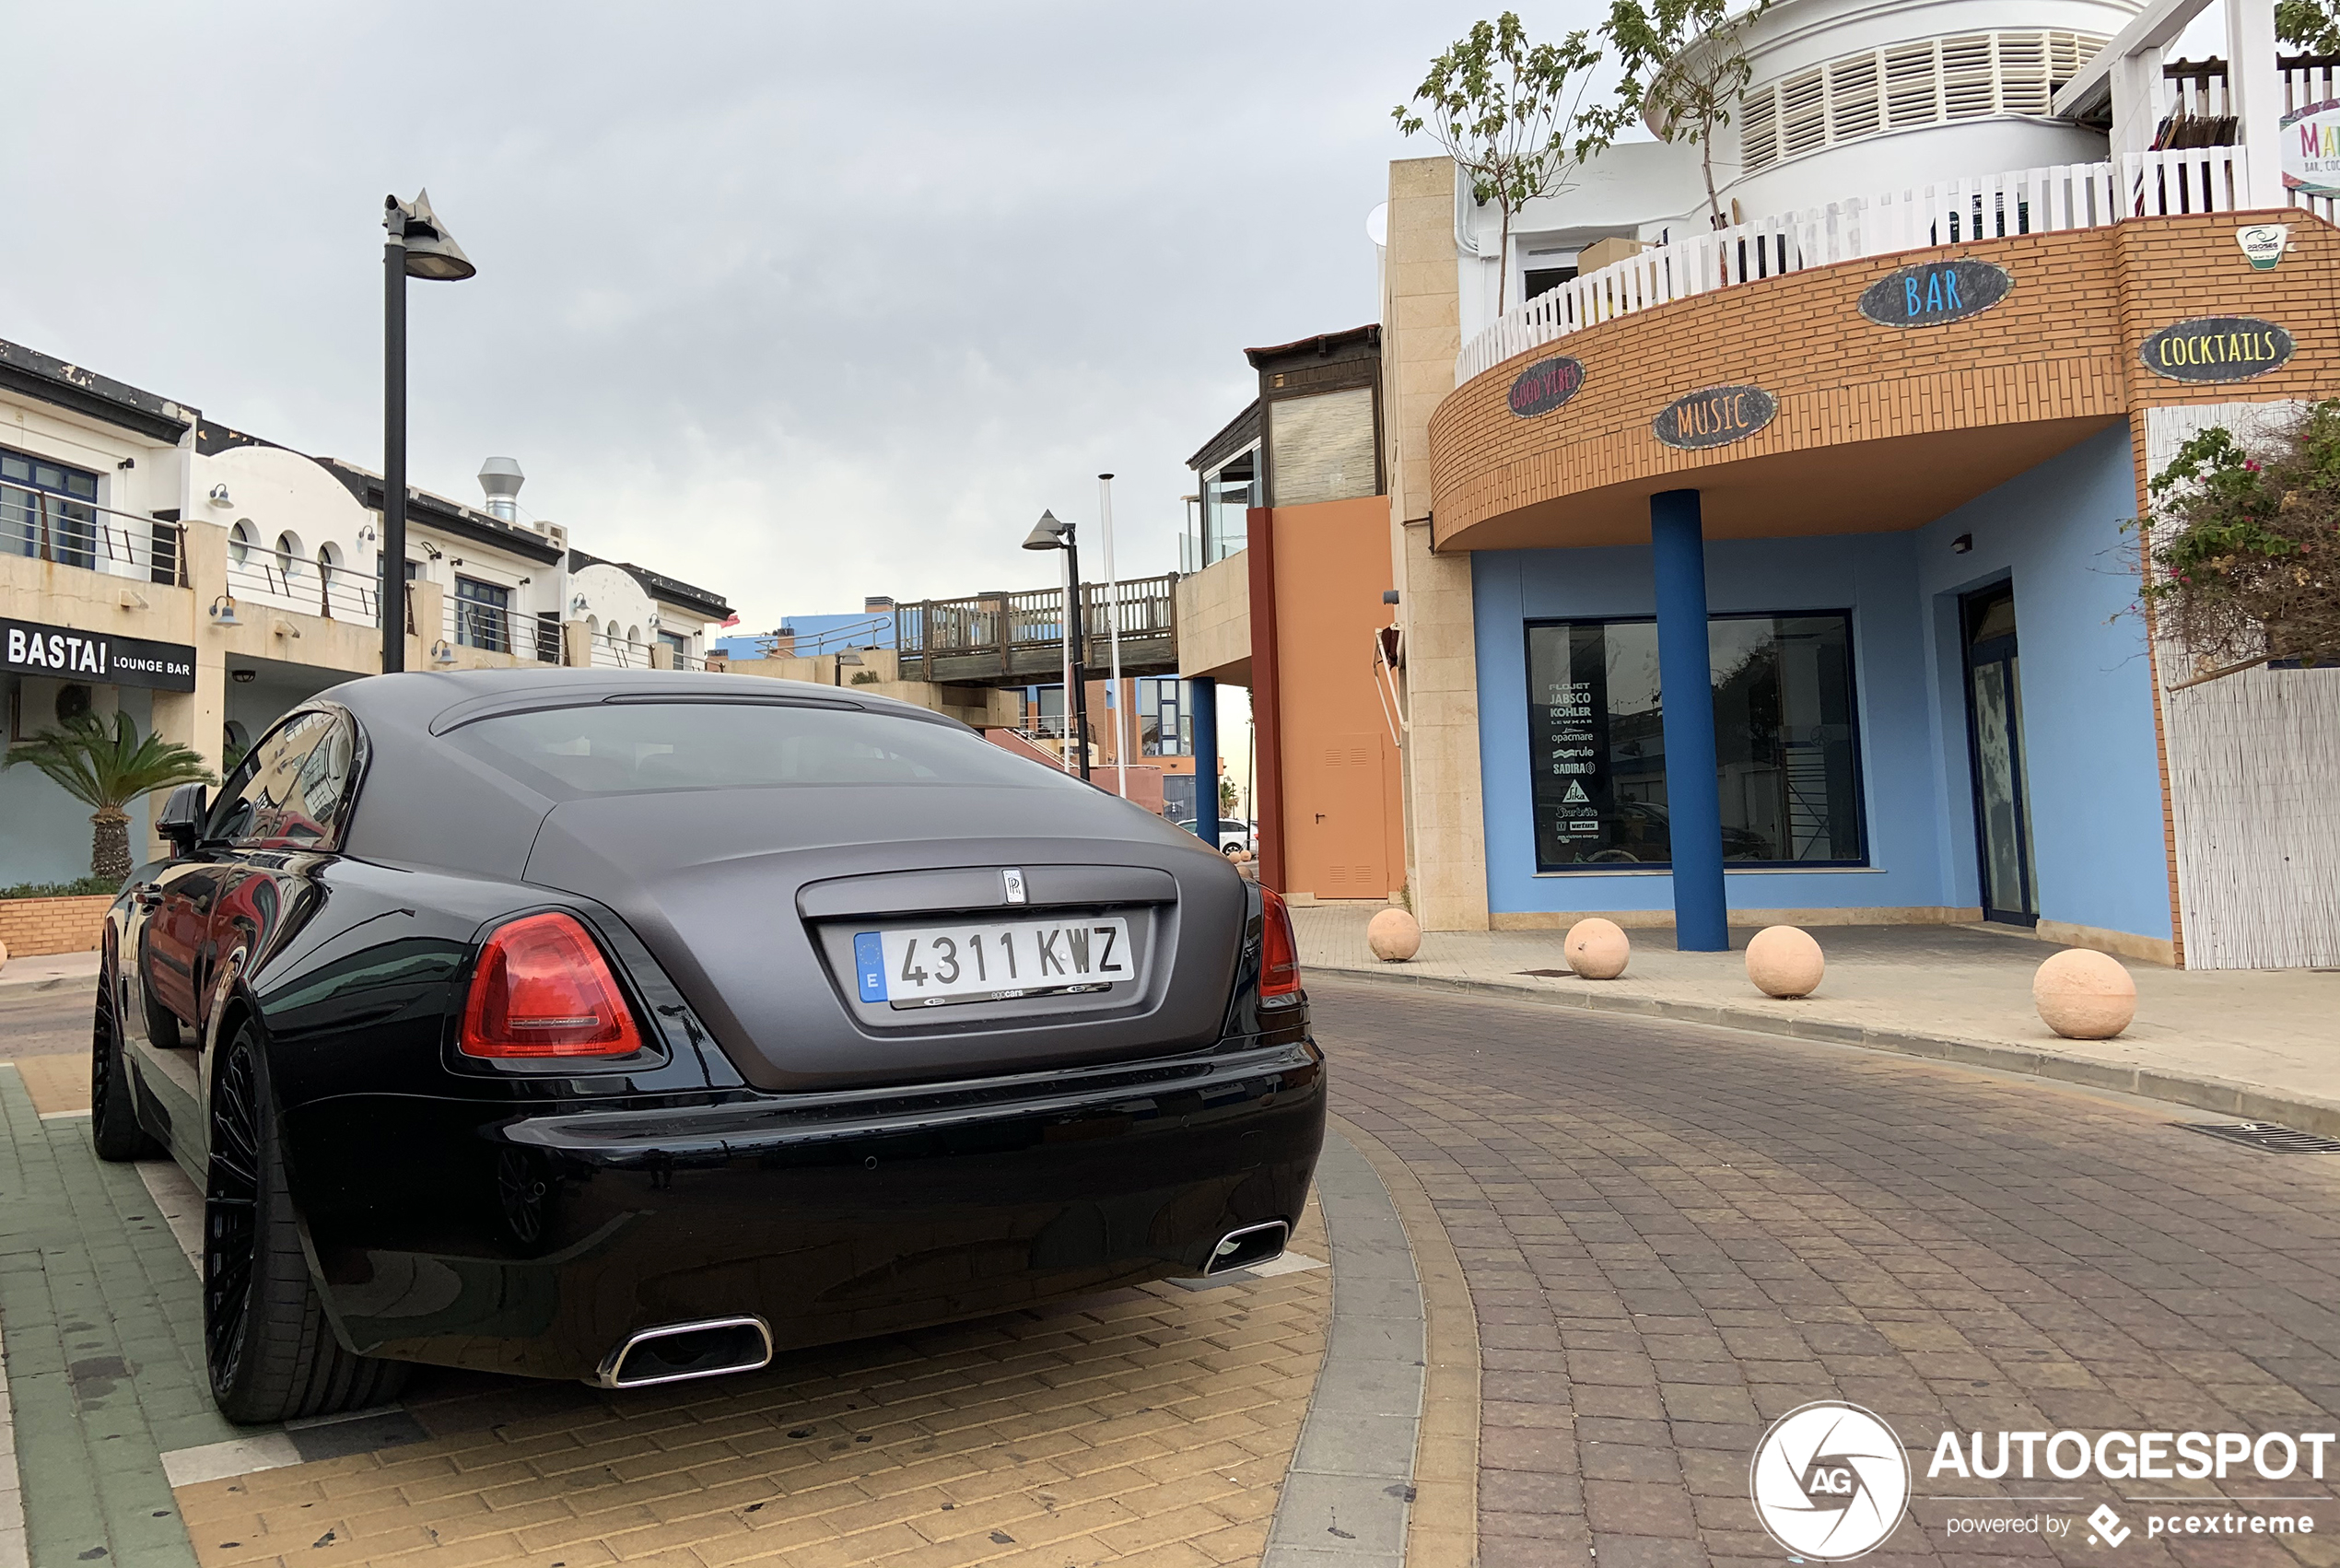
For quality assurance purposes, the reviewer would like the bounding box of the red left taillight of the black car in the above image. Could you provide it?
[463,915,641,1056]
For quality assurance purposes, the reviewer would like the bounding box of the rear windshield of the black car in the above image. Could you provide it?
[447,702,1081,798]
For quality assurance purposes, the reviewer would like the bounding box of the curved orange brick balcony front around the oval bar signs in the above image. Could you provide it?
[1430,211,2340,550]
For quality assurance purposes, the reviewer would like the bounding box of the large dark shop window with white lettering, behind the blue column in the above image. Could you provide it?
[1528,614,1867,871]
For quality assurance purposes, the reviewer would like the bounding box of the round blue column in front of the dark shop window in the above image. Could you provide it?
[1650,489,1732,953]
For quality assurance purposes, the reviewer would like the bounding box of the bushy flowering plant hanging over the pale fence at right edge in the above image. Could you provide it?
[2139,400,2340,685]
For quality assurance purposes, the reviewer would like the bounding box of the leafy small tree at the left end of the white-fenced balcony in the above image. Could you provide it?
[1390,12,1624,313]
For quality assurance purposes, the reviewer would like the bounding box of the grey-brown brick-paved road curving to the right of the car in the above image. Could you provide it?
[1310,976,2340,1568]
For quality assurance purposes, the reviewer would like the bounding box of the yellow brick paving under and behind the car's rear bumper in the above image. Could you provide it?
[176,1205,1331,1568]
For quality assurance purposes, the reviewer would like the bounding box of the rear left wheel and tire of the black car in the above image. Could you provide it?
[204,1023,407,1423]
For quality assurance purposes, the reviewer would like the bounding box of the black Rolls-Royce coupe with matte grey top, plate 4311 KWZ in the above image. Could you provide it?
[94,672,1325,1421]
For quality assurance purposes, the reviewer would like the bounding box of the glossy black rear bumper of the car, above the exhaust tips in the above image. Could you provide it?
[286,1044,1325,1378]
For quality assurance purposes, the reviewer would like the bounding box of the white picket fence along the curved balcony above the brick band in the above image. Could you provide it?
[1456,147,2249,386]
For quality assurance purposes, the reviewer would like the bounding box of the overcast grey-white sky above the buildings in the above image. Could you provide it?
[0,0,1589,629]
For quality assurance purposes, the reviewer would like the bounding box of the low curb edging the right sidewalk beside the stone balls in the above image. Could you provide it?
[1304,965,2340,1138]
